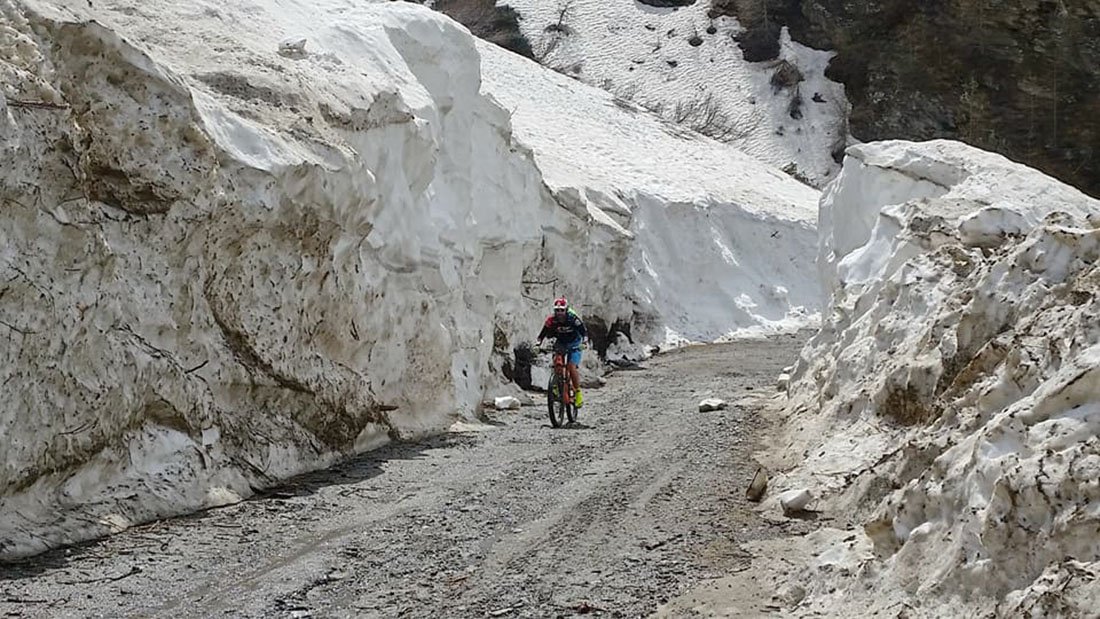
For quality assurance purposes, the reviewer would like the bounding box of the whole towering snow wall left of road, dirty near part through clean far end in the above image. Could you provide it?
[0,0,817,557]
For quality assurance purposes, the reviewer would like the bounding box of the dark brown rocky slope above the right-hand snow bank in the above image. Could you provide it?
[713,0,1100,196]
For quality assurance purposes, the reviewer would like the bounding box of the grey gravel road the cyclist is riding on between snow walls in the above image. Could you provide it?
[0,335,820,617]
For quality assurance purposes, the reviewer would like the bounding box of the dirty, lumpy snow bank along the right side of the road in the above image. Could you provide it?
[776,142,1100,616]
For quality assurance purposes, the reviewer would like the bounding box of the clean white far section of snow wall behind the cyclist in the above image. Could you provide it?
[479,43,821,344]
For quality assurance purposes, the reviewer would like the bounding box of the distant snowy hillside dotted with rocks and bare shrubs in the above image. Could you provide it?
[498,0,848,187]
